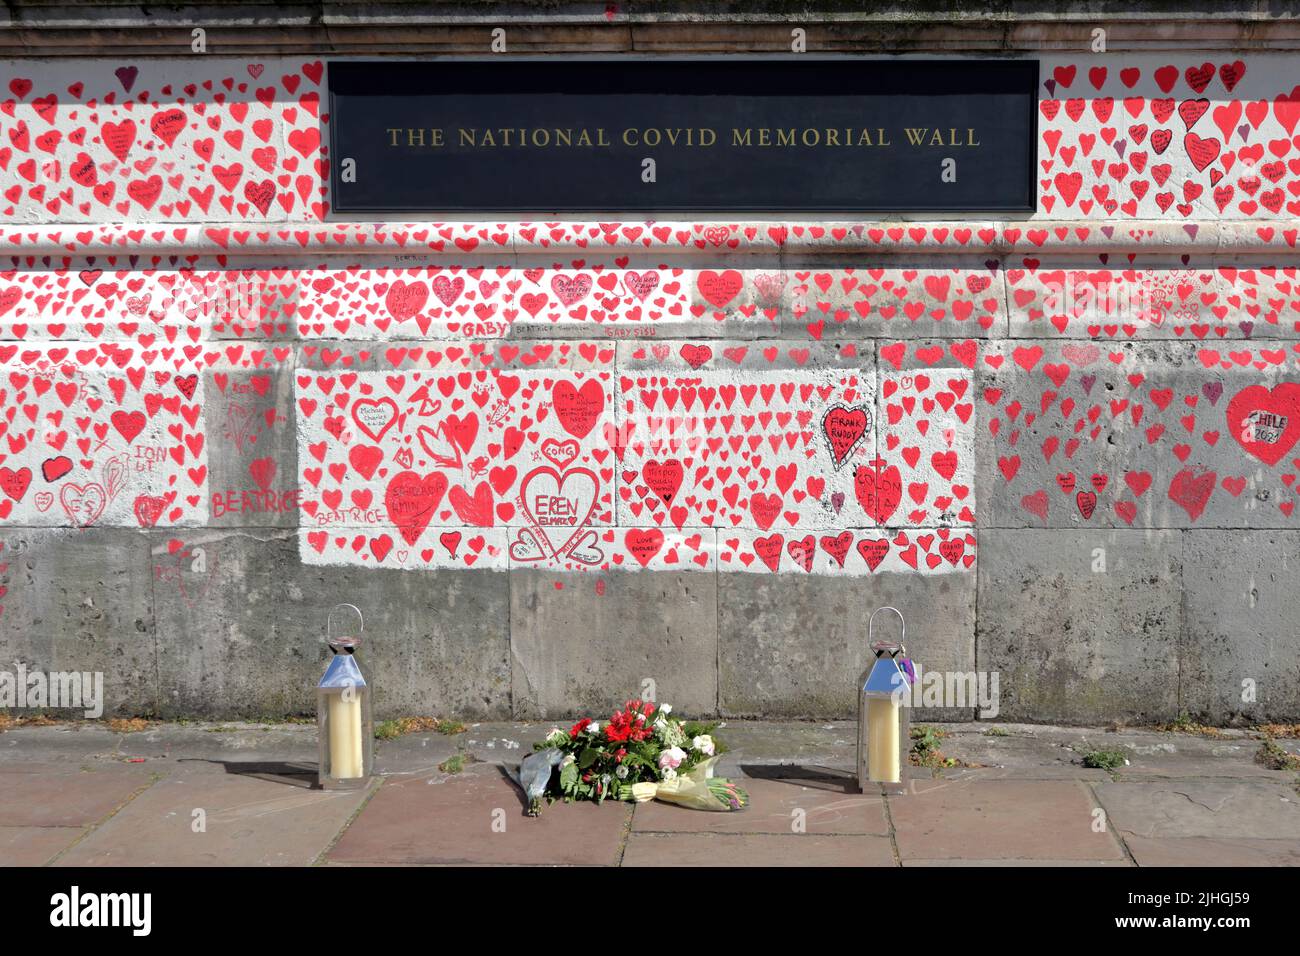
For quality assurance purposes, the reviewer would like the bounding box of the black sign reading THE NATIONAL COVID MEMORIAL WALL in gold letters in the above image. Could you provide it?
[329,59,1039,213]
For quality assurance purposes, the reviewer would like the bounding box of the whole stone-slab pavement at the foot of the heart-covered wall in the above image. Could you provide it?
[0,721,1300,866]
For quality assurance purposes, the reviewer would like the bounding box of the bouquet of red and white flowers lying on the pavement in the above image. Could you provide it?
[519,700,749,816]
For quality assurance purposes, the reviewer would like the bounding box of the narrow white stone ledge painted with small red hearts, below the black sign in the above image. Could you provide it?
[0,216,1300,260]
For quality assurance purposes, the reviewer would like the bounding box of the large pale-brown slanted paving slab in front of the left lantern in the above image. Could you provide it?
[59,763,365,866]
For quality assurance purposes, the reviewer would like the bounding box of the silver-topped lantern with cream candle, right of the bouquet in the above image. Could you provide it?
[857,607,911,793]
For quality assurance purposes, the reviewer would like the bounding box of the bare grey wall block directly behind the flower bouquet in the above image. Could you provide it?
[510,568,718,719]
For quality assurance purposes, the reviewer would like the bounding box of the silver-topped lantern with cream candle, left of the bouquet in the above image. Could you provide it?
[316,604,374,790]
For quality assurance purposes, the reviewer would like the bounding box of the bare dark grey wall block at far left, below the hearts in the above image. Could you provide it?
[0,528,159,717]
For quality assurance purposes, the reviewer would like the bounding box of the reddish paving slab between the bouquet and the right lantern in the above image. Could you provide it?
[632,777,889,834]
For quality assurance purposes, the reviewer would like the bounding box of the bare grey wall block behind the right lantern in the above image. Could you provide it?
[718,572,975,721]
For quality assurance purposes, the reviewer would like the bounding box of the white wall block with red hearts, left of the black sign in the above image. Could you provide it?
[0,56,325,225]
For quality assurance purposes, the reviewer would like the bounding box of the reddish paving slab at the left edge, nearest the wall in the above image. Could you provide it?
[0,765,153,827]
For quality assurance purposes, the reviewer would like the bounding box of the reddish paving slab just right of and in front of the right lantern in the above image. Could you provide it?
[889,780,1123,865]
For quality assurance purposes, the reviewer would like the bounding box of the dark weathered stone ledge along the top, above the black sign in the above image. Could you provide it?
[0,0,1300,56]
